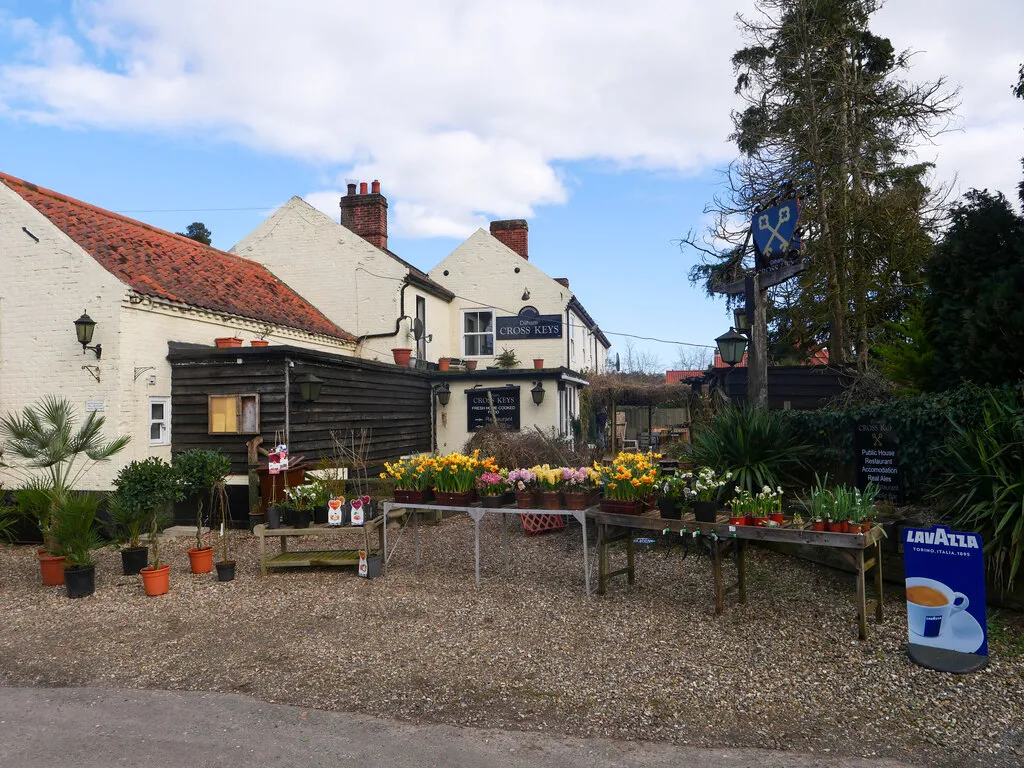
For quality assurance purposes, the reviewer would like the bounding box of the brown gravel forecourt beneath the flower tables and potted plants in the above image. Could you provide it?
[0,515,1024,766]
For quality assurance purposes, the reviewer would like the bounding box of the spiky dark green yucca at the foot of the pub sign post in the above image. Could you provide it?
[691,408,811,494]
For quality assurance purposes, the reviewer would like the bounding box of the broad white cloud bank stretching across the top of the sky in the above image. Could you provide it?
[0,0,1024,237]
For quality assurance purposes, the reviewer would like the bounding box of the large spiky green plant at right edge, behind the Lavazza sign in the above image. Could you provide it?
[933,390,1024,591]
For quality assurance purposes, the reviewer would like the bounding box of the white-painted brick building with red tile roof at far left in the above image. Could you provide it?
[0,174,355,489]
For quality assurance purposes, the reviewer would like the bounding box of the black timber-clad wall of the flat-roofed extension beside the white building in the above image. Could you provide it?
[170,348,431,474]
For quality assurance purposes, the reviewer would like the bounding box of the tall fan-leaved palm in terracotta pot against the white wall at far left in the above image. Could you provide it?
[0,395,130,589]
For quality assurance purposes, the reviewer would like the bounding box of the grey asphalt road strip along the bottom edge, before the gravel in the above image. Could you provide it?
[0,688,925,768]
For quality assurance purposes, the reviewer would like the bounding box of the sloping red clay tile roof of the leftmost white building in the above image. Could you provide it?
[0,173,354,341]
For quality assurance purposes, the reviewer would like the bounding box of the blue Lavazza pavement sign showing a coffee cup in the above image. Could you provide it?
[903,525,988,672]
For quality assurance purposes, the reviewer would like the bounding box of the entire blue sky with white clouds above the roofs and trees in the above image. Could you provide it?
[0,0,1024,368]
